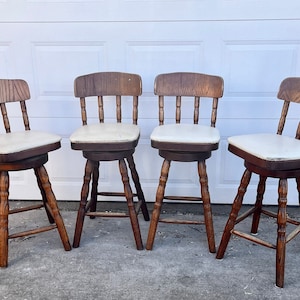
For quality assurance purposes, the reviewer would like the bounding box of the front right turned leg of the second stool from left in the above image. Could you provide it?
[119,159,144,250]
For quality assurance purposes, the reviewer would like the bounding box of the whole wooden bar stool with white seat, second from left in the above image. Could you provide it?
[70,72,149,250]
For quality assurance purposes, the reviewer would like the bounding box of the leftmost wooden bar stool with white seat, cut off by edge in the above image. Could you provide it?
[0,79,71,267]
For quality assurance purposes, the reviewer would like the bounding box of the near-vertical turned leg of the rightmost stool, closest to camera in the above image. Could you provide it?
[276,179,287,288]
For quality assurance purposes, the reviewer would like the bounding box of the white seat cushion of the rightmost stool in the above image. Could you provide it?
[228,133,300,161]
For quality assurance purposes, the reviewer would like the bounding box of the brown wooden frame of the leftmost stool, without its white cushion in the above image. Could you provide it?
[0,79,71,267]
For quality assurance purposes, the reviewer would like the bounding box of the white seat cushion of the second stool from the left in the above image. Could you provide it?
[70,123,140,144]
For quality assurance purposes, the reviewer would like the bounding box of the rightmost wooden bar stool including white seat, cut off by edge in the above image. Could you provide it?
[217,78,300,287]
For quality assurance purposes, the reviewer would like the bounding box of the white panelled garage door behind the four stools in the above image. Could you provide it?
[0,0,300,204]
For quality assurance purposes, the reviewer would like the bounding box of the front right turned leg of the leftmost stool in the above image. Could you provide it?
[36,166,71,251]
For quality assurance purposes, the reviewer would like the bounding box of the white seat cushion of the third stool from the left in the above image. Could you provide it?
[150,124,220,144]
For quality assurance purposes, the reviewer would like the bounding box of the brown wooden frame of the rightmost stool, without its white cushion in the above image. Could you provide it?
[216,78,300,287]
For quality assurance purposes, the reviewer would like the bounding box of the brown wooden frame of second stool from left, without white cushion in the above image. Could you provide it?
[71,72,149,250]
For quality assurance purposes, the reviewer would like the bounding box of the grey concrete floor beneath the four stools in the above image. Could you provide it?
[0,204,300,300]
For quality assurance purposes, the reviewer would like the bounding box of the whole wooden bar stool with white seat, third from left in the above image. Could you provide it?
[146,72,223,252]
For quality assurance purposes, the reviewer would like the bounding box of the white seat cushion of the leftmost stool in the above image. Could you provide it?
[0,130,61,155]
